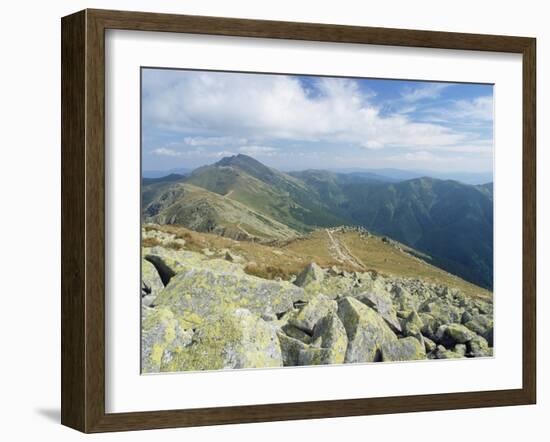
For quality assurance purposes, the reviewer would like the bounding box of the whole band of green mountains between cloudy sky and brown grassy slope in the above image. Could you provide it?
[142,155,493,290]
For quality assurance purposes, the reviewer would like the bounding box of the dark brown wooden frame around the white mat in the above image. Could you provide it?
[61,10,536,432]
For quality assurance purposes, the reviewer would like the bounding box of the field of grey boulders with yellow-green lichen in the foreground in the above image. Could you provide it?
[142,226,493,373]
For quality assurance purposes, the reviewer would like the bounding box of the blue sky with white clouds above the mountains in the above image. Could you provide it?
[142,68,493,172]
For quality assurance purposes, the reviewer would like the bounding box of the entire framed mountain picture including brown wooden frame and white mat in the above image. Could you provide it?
[61,10,536,432]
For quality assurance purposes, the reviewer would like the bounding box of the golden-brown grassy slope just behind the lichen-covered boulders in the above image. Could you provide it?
[147,226,492,297]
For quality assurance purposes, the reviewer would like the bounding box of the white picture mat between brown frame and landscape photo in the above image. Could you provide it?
[105,30,522,413]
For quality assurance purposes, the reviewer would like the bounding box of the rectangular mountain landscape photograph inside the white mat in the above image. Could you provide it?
[136,67,494,374]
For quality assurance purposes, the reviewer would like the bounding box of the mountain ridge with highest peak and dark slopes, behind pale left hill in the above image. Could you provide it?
[144,154,493,289]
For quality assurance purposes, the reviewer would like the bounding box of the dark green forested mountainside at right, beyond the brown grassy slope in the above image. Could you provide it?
[338,178,493,289]
